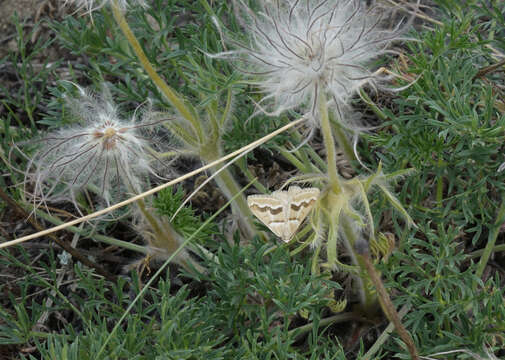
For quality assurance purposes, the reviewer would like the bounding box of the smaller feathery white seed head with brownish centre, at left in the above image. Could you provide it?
[25,87,171,211]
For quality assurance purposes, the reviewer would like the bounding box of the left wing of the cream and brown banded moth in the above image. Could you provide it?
[247,195,285,240]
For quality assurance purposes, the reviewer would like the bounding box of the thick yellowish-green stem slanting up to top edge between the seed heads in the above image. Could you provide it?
[111,0,201,134]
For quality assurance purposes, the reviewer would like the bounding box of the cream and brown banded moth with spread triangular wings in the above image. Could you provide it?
[247,186,319,242]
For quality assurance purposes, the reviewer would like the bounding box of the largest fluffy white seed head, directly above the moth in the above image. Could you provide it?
[217,0,406,122]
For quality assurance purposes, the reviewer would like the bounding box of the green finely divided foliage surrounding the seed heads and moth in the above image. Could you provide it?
[0,0,505,360]
